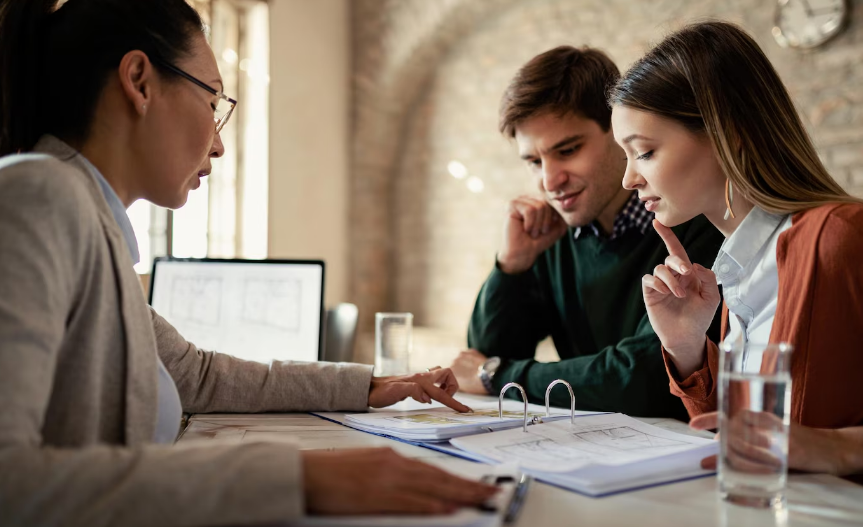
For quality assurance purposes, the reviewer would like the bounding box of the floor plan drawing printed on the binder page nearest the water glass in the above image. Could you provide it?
[495,426,686,462]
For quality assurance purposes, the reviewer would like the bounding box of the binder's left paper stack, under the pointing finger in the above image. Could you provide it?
[344,403,596,442]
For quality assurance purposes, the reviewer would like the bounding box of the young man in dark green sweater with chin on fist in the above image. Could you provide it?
[452,46,723,419]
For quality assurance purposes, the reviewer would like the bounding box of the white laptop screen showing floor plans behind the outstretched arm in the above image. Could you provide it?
[150,258,324,362]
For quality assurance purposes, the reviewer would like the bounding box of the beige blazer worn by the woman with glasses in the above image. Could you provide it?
[0,137,371,527]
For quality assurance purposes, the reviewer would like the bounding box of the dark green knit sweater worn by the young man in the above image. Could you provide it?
[468,216,723,420]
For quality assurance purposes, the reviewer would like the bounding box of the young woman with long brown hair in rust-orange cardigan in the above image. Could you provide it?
[609,22,863,474]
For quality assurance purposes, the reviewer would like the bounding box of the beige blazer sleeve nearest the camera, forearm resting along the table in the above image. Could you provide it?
[0,161,303,527]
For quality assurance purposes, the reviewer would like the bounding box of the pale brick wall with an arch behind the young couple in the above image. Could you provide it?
[350,0,863,364]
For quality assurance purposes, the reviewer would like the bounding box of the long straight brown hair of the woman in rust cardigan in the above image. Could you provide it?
[609,22,861,214]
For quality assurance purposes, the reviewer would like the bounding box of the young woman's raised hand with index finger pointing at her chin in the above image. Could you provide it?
[641,220,721,379]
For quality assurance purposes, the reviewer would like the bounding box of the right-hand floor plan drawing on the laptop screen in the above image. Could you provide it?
[241,278,303,333]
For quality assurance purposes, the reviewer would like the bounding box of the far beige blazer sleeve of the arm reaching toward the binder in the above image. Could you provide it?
[151,309,372,413]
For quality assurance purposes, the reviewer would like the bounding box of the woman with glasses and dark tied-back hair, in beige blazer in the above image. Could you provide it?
[0,0,495,525]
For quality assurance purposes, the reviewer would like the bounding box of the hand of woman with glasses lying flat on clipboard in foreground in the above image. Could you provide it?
[302,448,498,515]
